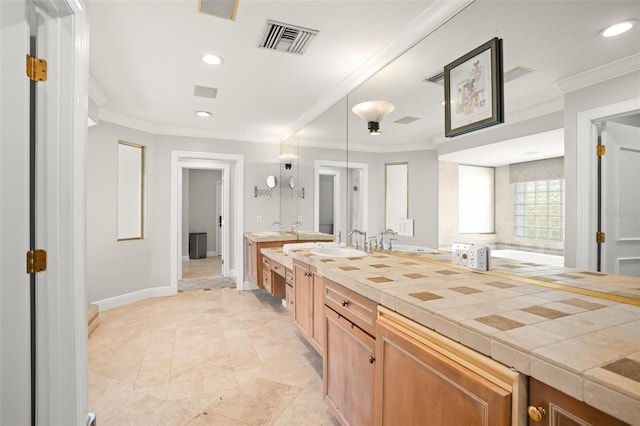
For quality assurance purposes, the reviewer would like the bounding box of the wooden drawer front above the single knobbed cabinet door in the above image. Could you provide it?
[324,279,378,336]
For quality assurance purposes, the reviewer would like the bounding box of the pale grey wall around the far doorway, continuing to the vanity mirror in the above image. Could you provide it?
[87,121,279,301]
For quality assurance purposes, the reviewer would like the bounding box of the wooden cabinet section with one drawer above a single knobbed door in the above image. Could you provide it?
[323,279,378,425]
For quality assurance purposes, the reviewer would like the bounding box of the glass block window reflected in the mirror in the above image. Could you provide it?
[513,179,564,241]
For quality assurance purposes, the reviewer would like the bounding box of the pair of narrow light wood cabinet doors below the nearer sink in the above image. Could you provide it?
[293,260,324,355]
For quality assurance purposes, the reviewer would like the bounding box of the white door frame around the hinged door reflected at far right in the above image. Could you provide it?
[575,98,640,270]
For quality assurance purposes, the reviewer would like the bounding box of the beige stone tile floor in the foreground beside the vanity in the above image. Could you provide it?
[89,288,338,426]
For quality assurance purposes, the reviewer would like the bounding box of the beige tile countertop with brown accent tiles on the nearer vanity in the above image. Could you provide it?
[282,249,640,425]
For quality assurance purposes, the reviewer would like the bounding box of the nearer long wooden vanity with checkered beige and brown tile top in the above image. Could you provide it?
[263,248,640,425]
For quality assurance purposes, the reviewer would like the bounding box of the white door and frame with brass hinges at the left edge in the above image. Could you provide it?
[0,0,89,424]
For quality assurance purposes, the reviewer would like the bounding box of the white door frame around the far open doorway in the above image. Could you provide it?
[169,150,244,294]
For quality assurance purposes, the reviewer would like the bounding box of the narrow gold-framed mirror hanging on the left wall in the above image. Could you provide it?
[117,141,144,241]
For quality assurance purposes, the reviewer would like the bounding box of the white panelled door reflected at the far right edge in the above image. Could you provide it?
[602,121,640,277]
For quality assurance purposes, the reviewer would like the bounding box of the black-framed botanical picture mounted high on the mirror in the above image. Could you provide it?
[444,37,504,137]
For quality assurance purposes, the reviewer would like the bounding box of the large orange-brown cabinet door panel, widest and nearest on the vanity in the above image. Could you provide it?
[376,322,511,426]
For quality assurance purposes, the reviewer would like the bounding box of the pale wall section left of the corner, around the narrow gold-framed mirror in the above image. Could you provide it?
[87,122,156,302]
